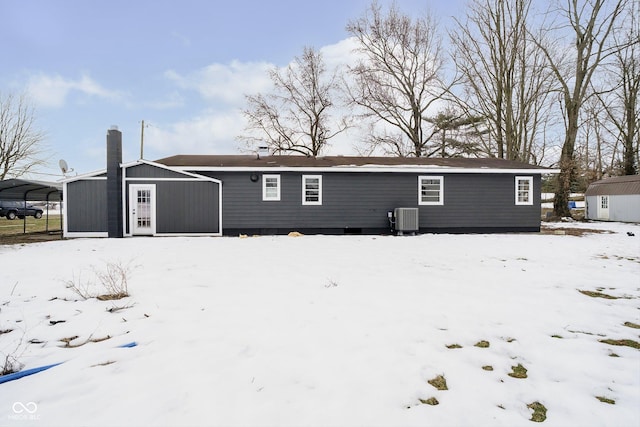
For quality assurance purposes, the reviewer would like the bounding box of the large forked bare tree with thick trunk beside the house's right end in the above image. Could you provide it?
[534,0,626,217]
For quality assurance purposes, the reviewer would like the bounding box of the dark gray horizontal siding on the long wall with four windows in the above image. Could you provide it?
[200,170,540,232]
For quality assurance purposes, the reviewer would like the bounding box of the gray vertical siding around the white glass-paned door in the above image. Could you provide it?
[125,181,220,234]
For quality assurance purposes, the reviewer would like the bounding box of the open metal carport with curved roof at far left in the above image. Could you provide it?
[0,179,62,233]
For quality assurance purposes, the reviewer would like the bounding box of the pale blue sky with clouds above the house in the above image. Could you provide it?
[0,0,464,180]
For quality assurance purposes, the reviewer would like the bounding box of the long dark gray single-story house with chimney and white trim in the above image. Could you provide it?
[64,129,557,237]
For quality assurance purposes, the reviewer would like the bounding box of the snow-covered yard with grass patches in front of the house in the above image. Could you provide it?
[0,223,640,426]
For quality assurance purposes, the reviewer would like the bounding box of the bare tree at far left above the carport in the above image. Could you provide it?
[0,93,45,180]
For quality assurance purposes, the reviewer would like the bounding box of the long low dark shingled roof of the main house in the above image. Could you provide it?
[156,155,552,172]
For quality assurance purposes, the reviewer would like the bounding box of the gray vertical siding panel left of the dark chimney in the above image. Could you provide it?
[64,180,107,233]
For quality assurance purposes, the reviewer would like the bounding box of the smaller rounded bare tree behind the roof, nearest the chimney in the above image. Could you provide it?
[239,47,348,157]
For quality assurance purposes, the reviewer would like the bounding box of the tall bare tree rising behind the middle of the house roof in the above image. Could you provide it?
[346,1,446,157]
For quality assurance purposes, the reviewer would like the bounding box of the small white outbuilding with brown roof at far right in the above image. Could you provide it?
[584,175,640,222]
